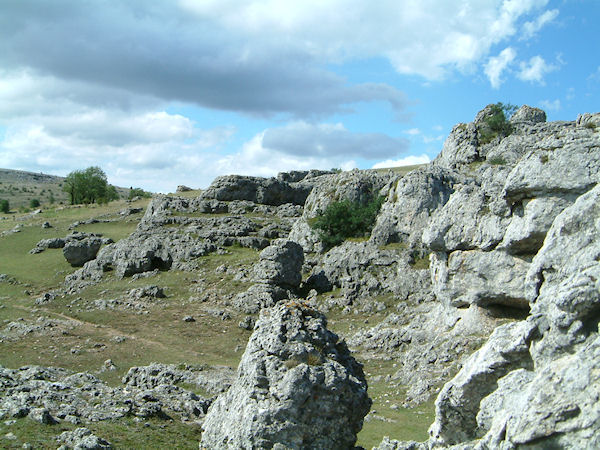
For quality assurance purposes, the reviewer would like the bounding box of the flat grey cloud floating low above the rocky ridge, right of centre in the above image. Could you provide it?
[262,122,409,159]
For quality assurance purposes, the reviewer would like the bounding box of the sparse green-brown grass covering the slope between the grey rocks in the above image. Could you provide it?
[0,177,433,448]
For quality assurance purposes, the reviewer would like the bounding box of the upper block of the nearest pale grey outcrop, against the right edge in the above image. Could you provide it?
[527,185,600,363]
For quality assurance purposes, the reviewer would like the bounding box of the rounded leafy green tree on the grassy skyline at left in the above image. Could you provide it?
[63,166,119,205]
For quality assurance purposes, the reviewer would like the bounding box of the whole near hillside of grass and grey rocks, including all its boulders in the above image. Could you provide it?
[0,106,600,450]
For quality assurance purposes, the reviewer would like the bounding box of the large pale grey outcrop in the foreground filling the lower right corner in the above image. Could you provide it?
[380,185,600,449]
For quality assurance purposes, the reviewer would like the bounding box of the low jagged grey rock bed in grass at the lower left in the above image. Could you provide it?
[0,364,232,424]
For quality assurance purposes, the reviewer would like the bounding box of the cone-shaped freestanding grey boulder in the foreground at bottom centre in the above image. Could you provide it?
[200,304,371,449]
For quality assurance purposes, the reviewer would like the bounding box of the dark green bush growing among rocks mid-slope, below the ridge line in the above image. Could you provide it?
[310,197,384,248]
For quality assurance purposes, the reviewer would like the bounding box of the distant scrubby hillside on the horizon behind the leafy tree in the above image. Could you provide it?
[0,169,129,210]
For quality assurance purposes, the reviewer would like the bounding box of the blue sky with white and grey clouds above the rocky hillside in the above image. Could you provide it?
[0,0,600,192]
